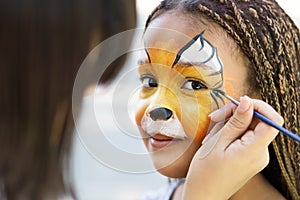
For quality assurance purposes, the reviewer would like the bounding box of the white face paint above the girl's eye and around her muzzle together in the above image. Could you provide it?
[141,32,223,139]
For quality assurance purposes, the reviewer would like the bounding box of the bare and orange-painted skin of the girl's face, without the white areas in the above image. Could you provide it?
[136,12,247,178]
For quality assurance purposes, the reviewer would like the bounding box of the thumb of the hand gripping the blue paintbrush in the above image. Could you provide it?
[219,96,254,146]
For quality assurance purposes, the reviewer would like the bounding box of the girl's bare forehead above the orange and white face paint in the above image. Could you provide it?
[144,9,235,57]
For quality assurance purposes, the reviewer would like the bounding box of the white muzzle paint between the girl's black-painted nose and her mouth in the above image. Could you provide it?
[141,113,187,139]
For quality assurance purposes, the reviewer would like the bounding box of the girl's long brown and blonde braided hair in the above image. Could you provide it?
[145,0,300,199]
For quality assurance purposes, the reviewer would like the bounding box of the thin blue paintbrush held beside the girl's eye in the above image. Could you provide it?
[218,90,300,142]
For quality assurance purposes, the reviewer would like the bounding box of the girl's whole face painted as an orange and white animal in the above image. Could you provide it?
[136,11,247,177]
